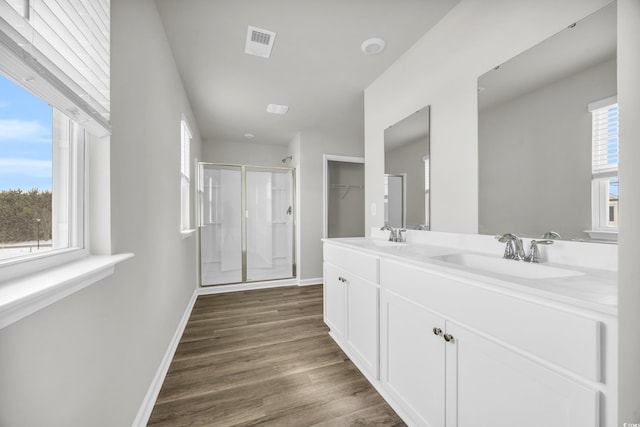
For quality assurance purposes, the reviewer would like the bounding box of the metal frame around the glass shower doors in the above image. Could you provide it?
[196,162,298,287]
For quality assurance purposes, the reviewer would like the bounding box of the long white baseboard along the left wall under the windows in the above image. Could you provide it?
[132,289,198,427]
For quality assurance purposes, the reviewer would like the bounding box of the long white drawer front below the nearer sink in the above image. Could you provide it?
[380,260,602,381]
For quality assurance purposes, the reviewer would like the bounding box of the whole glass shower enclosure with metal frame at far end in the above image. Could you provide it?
[198,163,296,286]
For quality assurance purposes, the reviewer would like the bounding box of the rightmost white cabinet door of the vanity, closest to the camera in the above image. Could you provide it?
[445,322,599,427]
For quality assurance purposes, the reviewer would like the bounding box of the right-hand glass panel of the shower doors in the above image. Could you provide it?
[246,167,295,282]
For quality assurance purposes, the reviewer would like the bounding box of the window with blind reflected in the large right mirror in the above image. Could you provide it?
[588,97,619,240]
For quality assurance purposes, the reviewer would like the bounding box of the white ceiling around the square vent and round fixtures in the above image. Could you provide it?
[156,0,459,144]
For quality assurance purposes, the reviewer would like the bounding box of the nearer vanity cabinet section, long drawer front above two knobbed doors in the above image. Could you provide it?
[380,260,602,427]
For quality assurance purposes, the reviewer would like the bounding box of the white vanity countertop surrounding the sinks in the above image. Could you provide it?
[324,237,618,315]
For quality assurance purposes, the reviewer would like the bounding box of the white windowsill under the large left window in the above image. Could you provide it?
[0,253,134,329]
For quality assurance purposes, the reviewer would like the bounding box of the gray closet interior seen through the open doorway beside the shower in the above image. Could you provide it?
[327,161,364,237]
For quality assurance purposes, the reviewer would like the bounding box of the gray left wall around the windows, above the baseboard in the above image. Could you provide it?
[0,0,200,427]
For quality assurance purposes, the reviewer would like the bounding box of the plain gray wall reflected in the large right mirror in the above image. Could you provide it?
[478,60,617,240]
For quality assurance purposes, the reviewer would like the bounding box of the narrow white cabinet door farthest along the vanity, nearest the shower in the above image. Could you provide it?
[324,263,347,341]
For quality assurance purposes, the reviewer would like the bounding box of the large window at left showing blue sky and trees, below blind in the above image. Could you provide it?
[0,76,85,264]
